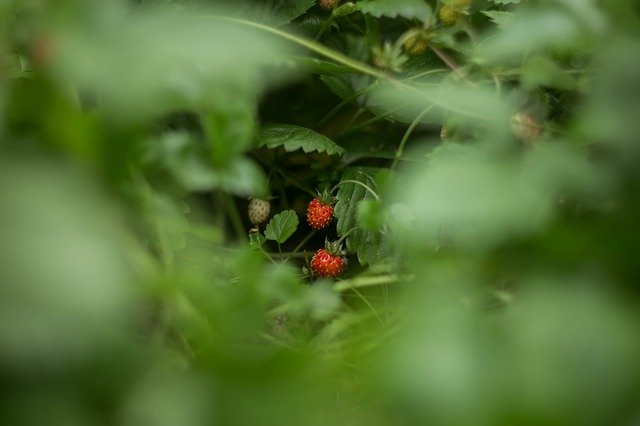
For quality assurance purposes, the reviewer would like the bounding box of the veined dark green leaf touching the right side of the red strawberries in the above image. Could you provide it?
[334,167,390,264]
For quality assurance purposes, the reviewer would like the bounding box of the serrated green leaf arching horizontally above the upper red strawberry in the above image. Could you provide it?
[258,124,344,155]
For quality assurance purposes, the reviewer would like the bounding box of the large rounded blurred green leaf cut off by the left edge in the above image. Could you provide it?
[0,156,137,370]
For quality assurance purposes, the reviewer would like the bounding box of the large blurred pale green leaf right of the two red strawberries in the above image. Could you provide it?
[395,143,607,249]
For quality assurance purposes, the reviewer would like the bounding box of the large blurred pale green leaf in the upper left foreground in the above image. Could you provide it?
[49,2,294,121]
